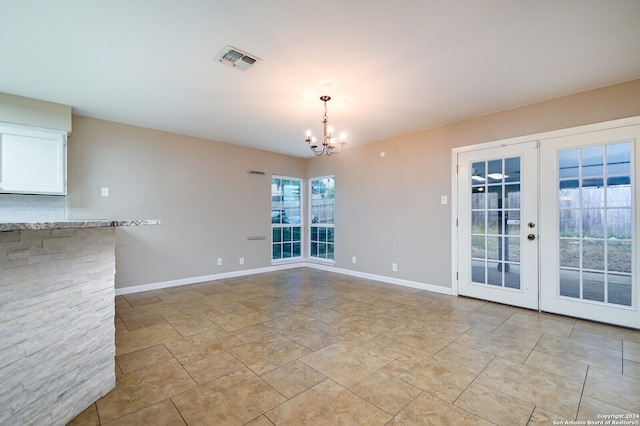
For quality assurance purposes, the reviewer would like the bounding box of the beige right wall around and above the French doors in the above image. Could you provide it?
[307,80,640,287]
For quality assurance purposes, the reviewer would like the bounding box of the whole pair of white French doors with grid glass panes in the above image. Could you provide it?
[456,125,640,328]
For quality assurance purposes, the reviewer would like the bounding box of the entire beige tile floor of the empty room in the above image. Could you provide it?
[70,268,640,426]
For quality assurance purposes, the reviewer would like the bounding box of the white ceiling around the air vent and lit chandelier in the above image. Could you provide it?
[0,0,640,157]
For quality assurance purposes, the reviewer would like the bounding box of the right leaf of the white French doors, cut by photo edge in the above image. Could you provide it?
[540,126,640,328]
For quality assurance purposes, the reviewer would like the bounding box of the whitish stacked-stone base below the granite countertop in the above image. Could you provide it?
[0,227,115,425]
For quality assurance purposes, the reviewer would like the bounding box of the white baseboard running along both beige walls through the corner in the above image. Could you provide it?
[116,262,453,296]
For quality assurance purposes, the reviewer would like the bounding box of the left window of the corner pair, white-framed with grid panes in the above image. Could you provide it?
[271,176,302,260]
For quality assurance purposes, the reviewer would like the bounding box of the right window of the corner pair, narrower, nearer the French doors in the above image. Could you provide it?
[309,176,335,260]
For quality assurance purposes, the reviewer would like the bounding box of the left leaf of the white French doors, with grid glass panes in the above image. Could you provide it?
[457,142,538,309]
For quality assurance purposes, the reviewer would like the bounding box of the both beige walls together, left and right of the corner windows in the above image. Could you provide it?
[68,80,640,288]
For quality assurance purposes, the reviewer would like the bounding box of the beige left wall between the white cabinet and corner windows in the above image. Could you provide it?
[67,115,305,288]
